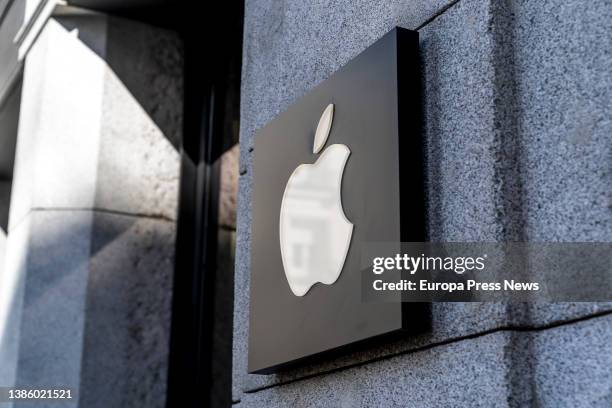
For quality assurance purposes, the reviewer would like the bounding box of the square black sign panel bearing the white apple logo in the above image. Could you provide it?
[249,28,424,373]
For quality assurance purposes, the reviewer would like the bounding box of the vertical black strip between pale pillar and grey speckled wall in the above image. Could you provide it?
[166,1,243,407]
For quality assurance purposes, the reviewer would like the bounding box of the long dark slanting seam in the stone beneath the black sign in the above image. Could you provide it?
[243,310,612,394]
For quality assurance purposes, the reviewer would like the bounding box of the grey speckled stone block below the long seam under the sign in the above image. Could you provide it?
[240,315,612,408]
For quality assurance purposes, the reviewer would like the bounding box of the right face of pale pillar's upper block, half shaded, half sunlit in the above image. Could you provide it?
[94,18,183,219]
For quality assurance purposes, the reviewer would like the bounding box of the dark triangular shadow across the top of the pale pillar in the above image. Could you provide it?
[57,13,183,150]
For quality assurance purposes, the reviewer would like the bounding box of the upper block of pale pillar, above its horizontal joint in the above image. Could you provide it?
[10,14,182,228]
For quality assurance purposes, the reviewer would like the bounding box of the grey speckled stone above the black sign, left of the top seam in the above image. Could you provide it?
[240,0,454,171]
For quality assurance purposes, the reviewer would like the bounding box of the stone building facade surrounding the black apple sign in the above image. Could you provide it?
[0,0,612,408]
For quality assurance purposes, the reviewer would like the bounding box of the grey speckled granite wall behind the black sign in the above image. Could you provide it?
[233,0,612,407]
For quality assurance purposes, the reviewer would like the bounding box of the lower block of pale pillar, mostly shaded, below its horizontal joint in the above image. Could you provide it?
[0,211,176,407]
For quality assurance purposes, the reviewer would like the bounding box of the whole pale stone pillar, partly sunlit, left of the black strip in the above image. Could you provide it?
[0,13,182,407]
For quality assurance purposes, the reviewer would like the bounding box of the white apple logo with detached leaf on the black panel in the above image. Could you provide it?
[279,104,353,296]
